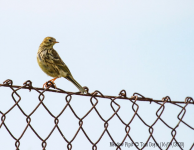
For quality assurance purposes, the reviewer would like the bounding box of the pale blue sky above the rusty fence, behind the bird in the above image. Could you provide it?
[0,0,194,150]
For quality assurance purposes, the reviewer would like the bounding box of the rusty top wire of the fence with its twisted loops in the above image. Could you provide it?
[0,79,194,104]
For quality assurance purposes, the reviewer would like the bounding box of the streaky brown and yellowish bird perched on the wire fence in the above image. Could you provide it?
[37,37,86,94]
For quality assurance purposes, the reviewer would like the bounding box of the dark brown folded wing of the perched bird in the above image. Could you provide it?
[48,49,71,75]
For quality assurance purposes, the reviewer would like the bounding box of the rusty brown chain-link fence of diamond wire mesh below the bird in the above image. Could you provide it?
[0,79,194,150]
